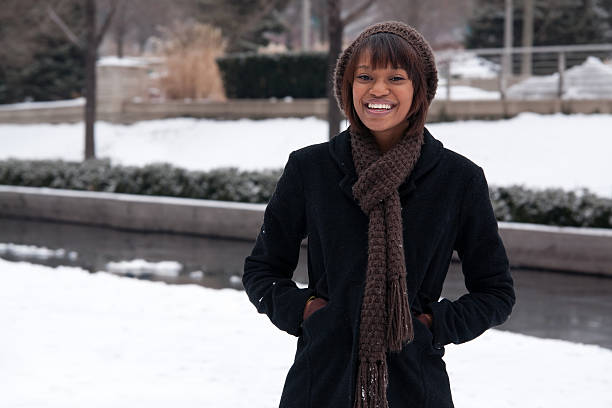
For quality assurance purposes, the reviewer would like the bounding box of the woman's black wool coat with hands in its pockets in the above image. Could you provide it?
[243,130,515,408]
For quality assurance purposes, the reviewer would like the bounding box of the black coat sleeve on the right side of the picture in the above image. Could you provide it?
[426,167,515,346]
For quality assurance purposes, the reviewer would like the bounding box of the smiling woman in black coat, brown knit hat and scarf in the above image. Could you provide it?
[243,22,515,408]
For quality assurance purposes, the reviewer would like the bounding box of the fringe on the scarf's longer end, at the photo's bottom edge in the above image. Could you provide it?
[354,356,389,408]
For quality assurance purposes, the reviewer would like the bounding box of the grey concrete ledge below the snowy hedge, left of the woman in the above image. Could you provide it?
[0,185,265,240]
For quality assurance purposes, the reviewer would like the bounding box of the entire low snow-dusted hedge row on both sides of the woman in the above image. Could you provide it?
[0,160,612,228]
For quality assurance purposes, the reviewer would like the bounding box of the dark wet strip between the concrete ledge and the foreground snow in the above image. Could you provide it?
[0,218,612,349]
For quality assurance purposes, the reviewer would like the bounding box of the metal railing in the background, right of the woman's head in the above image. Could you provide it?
[436,44,612,100]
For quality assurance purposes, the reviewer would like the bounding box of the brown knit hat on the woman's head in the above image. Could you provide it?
[334,21,438,112]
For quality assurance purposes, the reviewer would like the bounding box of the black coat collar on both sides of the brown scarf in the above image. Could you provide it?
[329,128,443,200]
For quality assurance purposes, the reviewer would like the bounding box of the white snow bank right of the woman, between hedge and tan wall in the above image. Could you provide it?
[428,113,612,197]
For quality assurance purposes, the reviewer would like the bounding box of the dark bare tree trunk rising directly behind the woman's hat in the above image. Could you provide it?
[326,0,375,139]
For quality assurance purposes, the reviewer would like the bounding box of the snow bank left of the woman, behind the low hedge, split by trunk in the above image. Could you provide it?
[0,118,327,170]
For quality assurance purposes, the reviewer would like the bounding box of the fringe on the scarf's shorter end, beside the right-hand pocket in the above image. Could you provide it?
[387,276,414,351]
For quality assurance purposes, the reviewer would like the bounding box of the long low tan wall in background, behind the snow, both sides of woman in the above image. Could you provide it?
[0,99,612,124]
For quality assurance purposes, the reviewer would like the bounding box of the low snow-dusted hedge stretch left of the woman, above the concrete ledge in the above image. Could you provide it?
[0,160,280,203]
